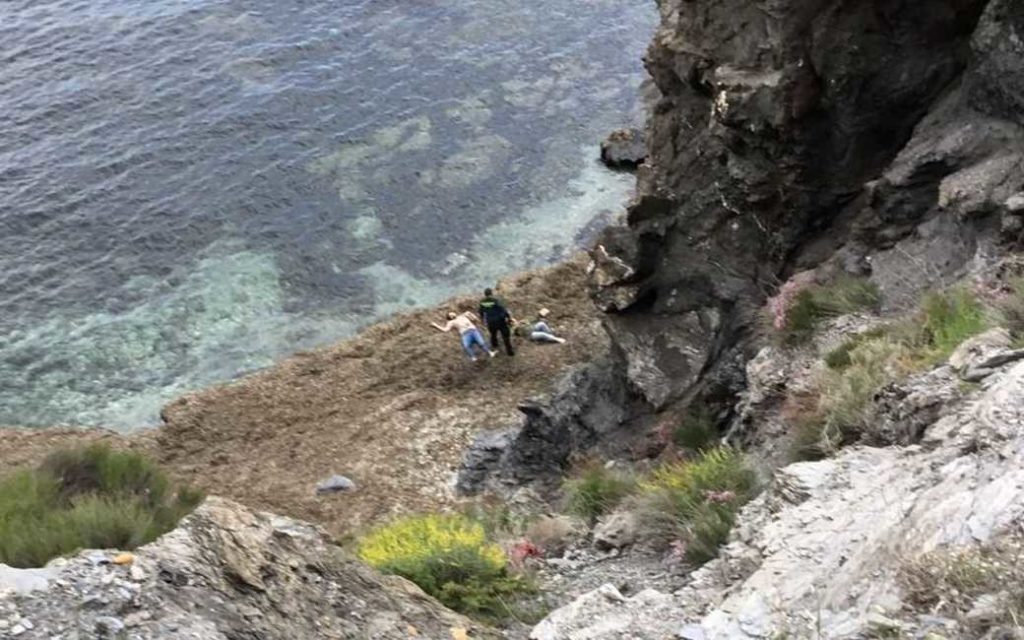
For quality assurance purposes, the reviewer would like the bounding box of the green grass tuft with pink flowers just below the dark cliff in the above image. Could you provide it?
[778,275,882,346]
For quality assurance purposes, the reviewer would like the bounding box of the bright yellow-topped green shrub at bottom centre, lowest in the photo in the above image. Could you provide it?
[358,514,534,621]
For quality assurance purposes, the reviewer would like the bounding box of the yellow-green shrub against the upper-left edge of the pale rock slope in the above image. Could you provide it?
[635,446,757,564]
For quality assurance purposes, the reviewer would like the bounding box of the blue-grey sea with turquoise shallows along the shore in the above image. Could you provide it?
[0,0,655,428]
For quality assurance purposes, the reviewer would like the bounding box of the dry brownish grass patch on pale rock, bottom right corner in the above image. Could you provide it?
[899,536,1024,638]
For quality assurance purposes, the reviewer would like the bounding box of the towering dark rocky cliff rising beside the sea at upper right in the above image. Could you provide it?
[483,0,1024,475]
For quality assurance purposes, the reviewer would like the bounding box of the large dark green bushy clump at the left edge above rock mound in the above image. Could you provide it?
[0,444,203,567]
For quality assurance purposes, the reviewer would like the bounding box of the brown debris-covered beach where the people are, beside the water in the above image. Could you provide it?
[0,257,608,535]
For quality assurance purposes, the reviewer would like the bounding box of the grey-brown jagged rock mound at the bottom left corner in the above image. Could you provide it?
[0,498,492,640]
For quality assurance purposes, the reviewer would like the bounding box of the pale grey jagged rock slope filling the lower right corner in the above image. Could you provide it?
[535,356,1024,640]
